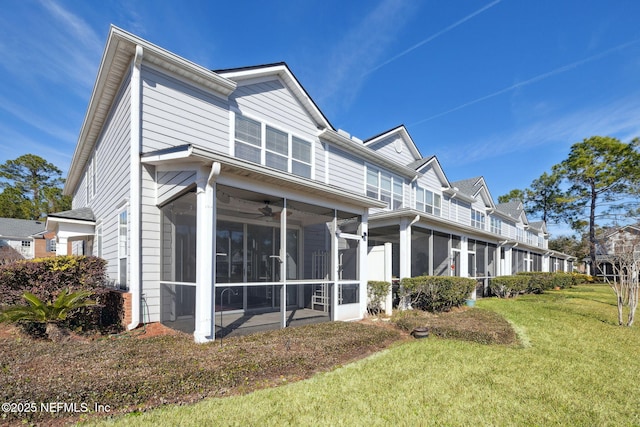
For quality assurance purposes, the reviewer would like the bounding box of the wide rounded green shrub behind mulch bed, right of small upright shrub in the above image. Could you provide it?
[400,276,476,312]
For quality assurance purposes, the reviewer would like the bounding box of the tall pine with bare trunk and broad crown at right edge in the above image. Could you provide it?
[553,136,640,266]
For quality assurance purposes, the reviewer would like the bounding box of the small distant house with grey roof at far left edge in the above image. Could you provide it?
[0,218,56,264]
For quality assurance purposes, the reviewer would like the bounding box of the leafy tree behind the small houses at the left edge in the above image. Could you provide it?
[0,154,71,219]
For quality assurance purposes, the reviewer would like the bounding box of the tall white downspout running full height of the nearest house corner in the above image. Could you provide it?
[127,45,144,330]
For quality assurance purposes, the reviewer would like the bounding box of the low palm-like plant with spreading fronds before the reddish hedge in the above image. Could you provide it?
[0,289,96,341]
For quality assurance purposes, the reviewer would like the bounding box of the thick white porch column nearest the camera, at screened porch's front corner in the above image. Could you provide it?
[193,163,220,343]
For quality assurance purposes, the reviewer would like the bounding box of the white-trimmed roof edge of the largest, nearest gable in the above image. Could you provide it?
[214,62,334,129]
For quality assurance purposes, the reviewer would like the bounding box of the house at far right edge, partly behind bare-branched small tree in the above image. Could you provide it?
[595,223,640,282]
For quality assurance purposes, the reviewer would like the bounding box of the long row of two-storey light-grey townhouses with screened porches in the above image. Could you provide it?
[48,27,571,342]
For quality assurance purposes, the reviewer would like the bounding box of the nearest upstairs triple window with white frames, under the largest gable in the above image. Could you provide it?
[234,114,312,178]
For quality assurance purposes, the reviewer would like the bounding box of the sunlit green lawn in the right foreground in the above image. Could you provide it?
[95,285,640,426]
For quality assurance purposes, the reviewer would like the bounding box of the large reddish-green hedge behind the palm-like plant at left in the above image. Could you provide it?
[0,255,124,332]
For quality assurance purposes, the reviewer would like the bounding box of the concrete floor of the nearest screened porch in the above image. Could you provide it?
[162,308,331,338]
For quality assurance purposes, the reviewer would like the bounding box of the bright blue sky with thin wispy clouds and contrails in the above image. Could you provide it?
[0,0,640,234]
